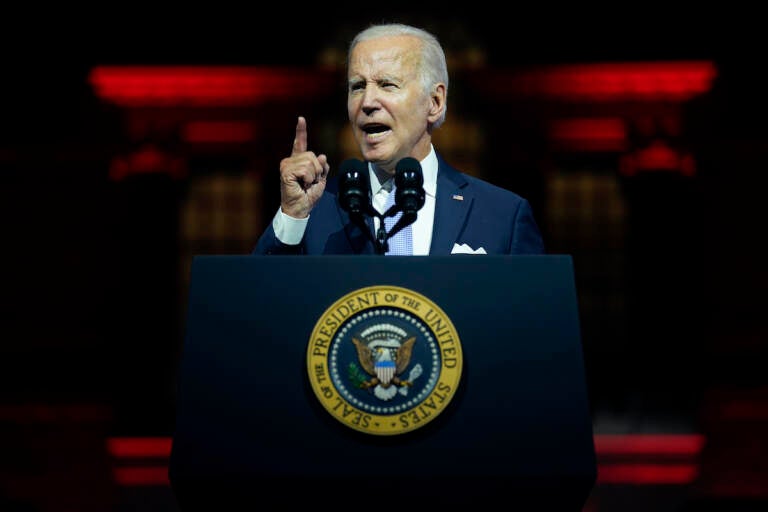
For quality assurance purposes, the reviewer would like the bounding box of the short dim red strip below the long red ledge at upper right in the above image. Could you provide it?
[549,118,627,152]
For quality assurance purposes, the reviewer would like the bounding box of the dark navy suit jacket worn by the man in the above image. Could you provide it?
[253,154,544,255]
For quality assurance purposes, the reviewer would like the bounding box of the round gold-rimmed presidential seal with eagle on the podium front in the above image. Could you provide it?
[307,286,463,436]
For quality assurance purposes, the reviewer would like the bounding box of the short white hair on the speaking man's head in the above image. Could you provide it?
[347,23,448,128]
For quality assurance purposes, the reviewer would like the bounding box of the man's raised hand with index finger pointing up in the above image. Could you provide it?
[280,116,330,219]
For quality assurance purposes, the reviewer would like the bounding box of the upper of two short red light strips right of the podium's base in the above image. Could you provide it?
[594,434,705,456]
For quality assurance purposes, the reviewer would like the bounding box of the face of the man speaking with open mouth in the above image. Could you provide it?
[347,36,432,173]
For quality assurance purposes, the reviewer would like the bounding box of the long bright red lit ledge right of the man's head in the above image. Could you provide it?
[478,61,717,101]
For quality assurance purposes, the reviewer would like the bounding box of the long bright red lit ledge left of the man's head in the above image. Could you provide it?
[88,66,336,107]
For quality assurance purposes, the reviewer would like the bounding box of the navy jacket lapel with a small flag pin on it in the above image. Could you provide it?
[429,155,474,256]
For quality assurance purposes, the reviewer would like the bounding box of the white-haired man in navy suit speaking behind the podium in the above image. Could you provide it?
[253,24,544,255]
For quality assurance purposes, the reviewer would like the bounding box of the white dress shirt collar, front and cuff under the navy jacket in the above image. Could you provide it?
[272,146,437,256]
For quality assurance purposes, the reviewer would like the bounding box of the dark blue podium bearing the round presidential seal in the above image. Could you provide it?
[169,255,596,511]
